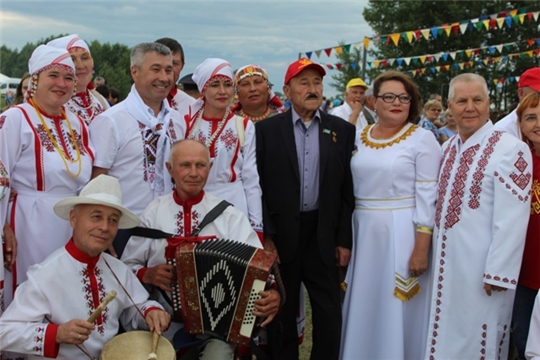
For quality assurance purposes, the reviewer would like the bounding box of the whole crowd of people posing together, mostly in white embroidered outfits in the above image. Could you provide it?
[0,35,540,360]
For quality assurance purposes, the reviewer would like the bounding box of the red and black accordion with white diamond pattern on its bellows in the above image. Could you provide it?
[176,240,277,345]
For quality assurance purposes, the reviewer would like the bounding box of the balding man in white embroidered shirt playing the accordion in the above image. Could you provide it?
[122,139,281,360]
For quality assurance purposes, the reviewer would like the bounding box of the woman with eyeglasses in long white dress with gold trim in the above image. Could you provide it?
[341,71,441,360]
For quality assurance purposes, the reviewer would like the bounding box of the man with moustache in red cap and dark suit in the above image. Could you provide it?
[255,58,355,360]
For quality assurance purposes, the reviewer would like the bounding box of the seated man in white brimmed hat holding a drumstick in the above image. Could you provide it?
[0,175,170,359]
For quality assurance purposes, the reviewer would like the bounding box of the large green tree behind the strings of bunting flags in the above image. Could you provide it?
[350,0,538,107]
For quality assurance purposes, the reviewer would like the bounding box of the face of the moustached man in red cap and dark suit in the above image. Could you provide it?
[283,69,323,115]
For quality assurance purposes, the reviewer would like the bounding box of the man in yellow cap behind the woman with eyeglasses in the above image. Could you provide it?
[332,78,368,132]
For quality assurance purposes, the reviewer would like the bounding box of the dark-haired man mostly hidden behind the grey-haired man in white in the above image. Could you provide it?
[155,38,195,115]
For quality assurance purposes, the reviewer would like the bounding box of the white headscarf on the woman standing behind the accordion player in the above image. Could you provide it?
[189,58,234,118]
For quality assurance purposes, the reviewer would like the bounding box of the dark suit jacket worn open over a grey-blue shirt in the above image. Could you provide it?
[255,110,355,266]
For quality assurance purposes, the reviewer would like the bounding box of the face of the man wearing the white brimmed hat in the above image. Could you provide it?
[69,204,122,257]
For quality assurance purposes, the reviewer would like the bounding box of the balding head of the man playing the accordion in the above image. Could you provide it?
[167,140,210,201]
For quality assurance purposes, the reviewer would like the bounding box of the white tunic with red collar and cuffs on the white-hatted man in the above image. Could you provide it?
[0,241,162,360]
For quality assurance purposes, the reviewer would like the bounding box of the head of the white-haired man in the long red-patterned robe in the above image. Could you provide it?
[448,81,489,141]
